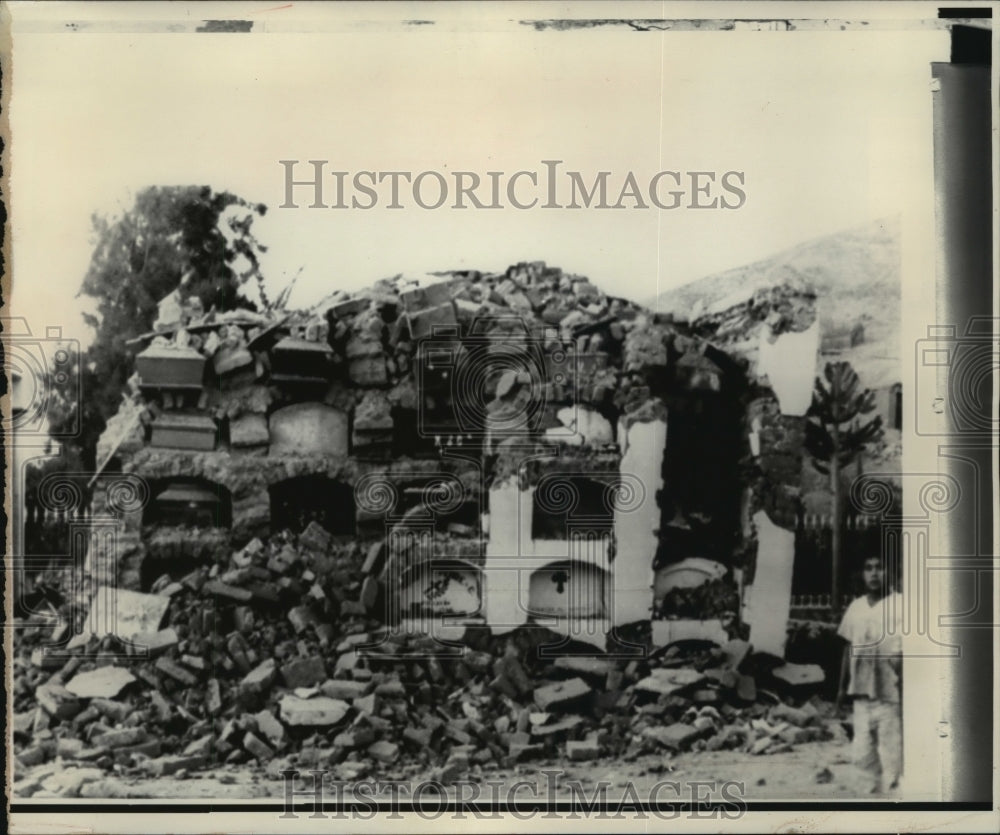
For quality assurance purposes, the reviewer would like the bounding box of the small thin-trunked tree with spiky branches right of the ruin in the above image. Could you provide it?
[805,362,883,609]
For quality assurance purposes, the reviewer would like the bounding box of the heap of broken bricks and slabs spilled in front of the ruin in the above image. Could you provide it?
[13,523,837,796]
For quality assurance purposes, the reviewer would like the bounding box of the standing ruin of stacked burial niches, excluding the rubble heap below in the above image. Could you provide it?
[93,263,819,656]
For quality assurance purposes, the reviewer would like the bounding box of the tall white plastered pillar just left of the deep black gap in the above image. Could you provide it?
[611,419,667,626]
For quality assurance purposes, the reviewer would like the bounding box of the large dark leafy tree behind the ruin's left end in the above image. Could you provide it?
[48,186,267,470]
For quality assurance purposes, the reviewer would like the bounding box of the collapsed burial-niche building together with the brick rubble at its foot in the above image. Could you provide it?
[13,262,843,796]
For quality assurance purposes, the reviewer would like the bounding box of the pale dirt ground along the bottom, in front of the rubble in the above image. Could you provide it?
[32,741,900,804]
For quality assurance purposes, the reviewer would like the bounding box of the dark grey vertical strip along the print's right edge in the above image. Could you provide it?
[928,57,996,802]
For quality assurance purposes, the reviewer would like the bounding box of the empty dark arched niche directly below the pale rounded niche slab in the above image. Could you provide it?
[268,475,355,536]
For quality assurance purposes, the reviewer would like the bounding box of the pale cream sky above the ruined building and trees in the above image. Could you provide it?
[5,4,947,342]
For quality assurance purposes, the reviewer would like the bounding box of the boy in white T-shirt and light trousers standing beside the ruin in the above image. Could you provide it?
[838,556,903,793]
